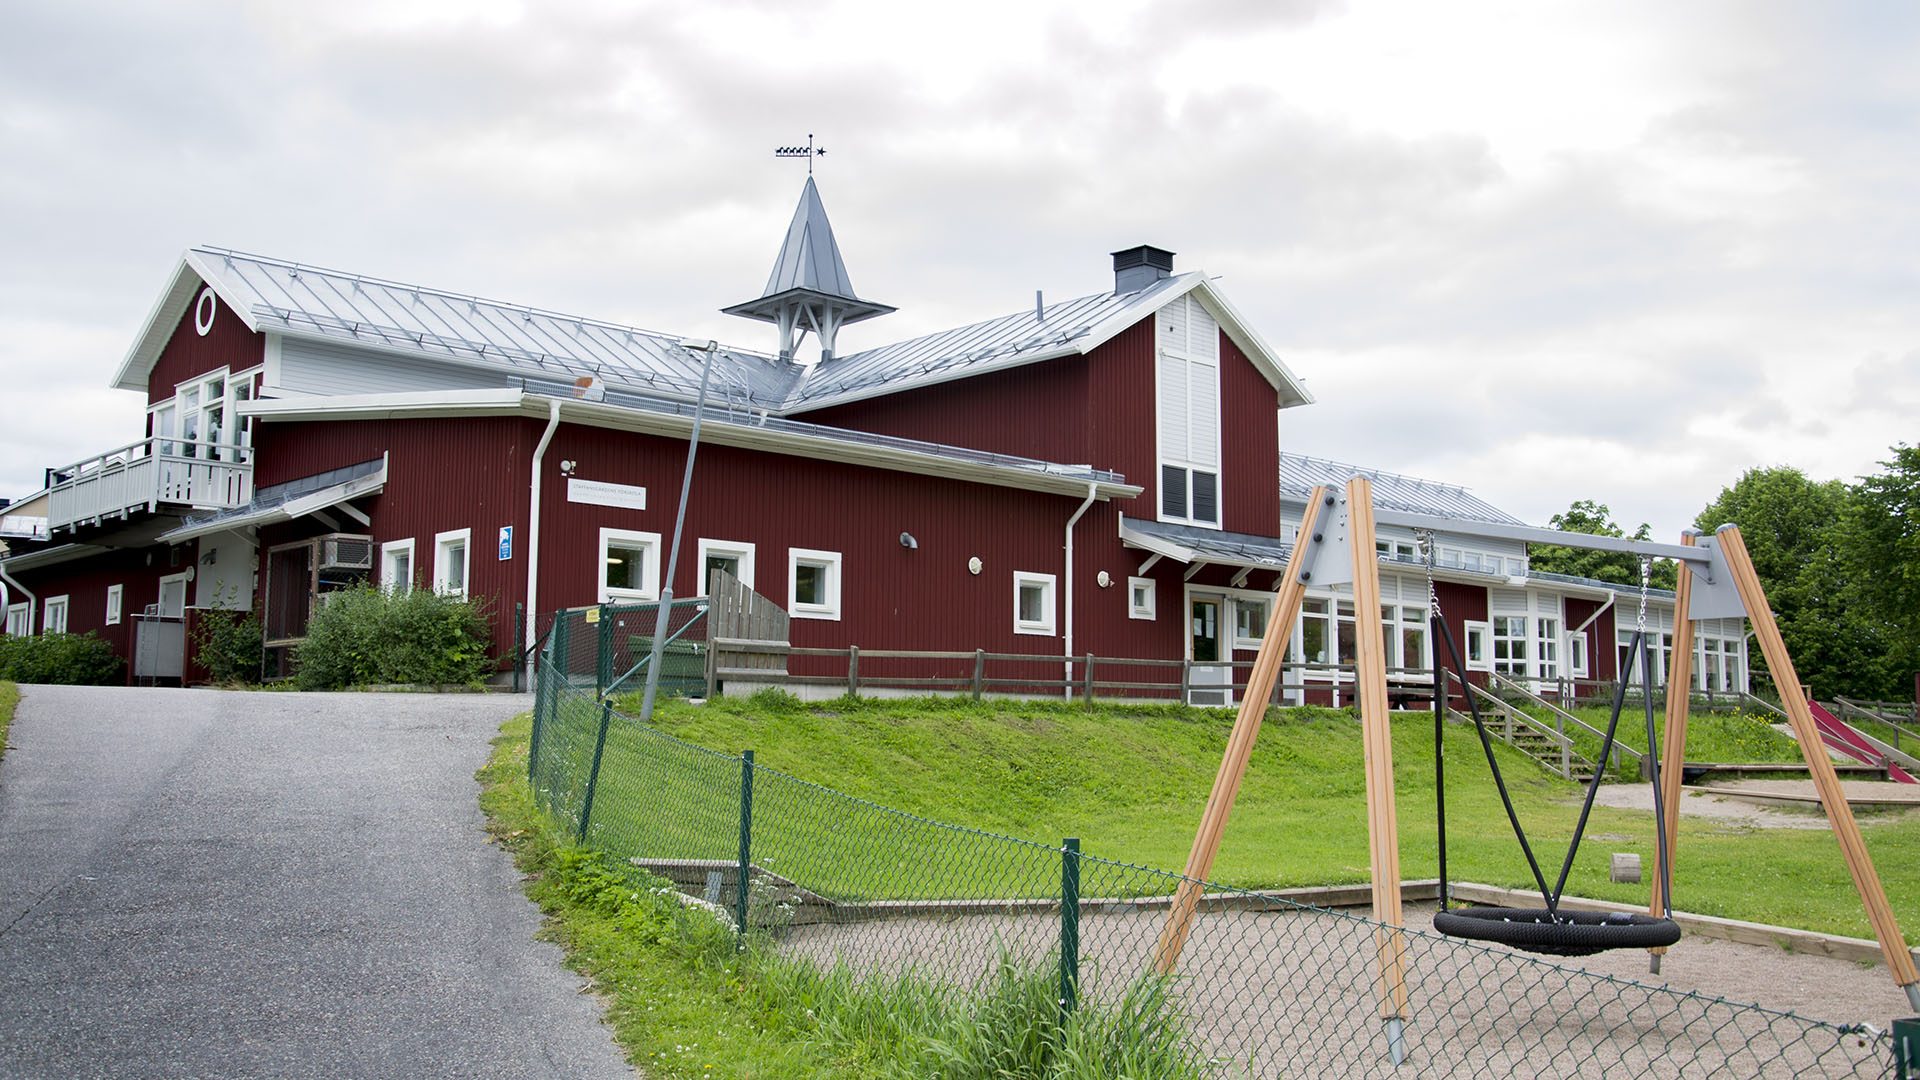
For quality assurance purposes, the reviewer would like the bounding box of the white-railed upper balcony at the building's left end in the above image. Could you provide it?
[46,438,253,532]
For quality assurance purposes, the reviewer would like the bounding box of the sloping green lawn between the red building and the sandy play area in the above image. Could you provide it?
[586,684,1920,938]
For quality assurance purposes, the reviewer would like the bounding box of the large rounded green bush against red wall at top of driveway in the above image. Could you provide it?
[294,586,493,690]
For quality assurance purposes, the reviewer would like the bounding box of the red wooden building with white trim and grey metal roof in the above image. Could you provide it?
[0,179,1743,701]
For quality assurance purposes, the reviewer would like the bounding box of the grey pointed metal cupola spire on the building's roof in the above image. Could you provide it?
[722,177,893,361]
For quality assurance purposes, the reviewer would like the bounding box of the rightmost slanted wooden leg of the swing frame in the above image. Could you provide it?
[1720,525,1920,1007]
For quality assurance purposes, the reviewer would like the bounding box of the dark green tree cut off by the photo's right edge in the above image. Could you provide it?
[1837,444,1920,698]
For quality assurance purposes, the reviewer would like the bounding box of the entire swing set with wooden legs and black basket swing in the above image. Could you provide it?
[1154,477,1920,1065]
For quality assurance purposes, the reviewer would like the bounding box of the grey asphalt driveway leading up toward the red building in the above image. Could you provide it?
[0,686,634,1078]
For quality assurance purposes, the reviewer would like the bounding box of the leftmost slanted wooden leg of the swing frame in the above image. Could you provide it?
[1154,488,1328,974]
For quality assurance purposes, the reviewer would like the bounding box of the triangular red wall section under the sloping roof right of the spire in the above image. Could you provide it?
[795,357,1089,463]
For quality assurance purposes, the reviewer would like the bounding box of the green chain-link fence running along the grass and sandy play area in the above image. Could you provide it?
[530,642,1895,1076]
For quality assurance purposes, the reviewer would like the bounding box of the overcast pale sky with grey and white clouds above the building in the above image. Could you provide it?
[0,0,1920,534]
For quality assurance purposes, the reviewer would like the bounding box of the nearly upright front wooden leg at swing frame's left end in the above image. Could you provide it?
[1346,477,1407,1022]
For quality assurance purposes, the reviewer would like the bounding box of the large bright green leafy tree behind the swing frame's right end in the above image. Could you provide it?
[1695,465,1887,694]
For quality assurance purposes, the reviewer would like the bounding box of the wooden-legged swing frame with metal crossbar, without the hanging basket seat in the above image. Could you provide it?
[1154,477,1920,1022]
